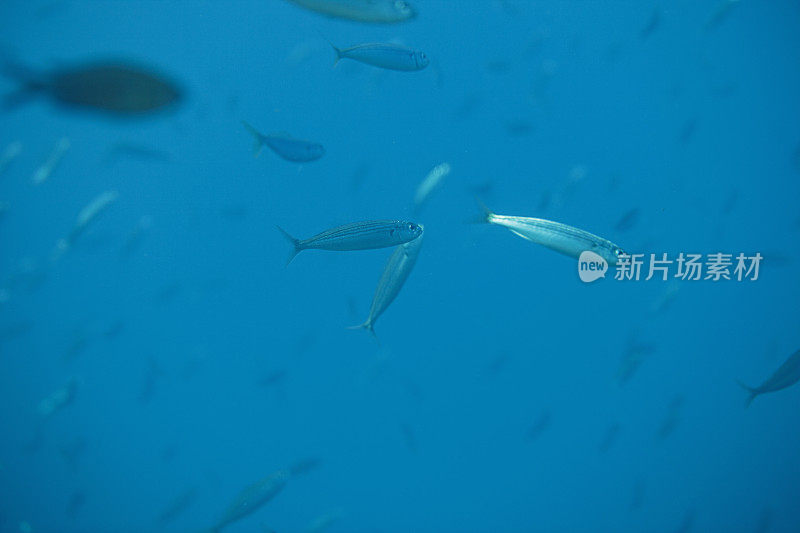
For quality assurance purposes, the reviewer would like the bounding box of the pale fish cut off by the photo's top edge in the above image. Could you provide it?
[289,0,417,24]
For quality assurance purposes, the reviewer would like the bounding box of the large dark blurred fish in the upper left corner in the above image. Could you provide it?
[4,61,181,116]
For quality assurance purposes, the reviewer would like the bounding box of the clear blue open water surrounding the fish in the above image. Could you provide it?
[0,0,800,533]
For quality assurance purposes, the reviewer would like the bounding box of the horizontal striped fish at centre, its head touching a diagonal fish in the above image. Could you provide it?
[278,220,422,265]
